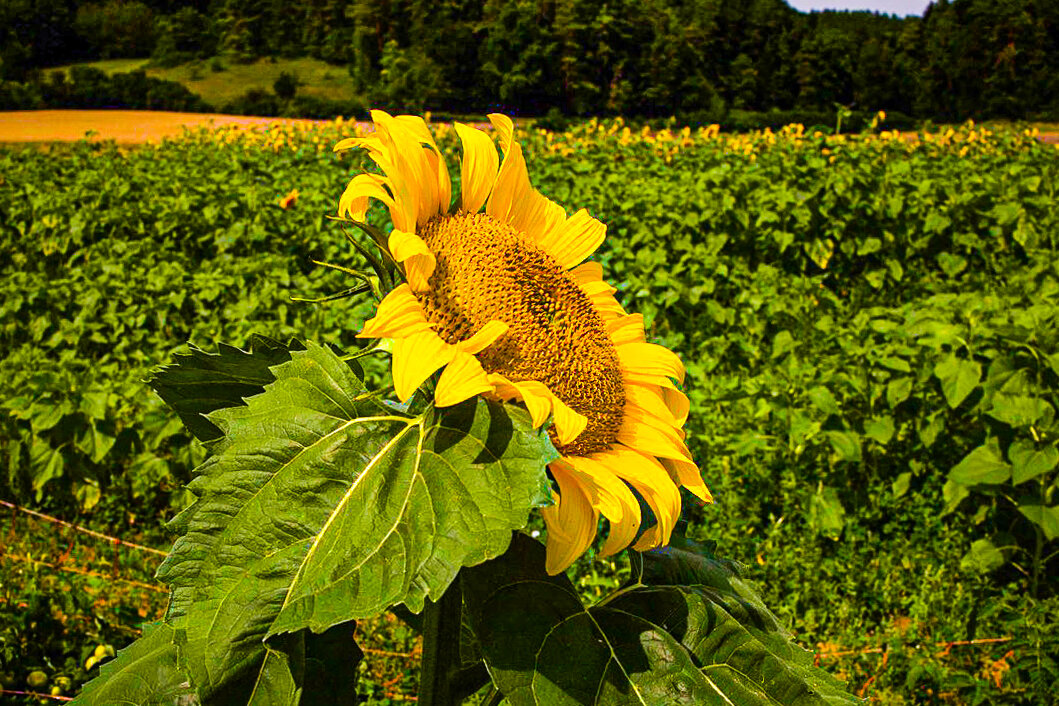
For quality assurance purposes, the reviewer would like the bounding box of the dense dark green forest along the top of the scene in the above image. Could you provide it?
[0,0,1059,121]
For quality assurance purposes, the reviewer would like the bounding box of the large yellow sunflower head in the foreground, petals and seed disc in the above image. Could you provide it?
[335,111,712,574]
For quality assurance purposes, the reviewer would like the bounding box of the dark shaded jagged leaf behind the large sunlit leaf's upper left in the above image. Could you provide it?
[147,336,303,441]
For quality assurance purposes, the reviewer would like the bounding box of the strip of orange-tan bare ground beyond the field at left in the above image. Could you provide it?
[0,110,330,144]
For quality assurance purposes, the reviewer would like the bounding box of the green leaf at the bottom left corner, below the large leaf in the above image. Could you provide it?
[73,623,191,706]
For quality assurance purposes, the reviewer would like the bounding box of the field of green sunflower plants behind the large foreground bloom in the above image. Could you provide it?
[0,121,1059,705]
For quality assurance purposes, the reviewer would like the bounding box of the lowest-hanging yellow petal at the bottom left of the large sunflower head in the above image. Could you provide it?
[541,466,599,576]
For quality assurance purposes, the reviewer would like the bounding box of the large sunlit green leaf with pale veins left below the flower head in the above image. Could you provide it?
[159,344,555,703]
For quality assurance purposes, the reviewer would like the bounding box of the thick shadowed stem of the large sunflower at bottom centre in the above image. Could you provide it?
[419,581,463,706]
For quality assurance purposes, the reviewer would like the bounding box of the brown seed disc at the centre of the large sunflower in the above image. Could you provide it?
[416,214,625,456]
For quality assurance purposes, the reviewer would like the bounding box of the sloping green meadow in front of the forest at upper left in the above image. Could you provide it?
[46,58,357,108]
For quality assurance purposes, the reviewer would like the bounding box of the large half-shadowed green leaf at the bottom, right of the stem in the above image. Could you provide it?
[463,536,858,706]
